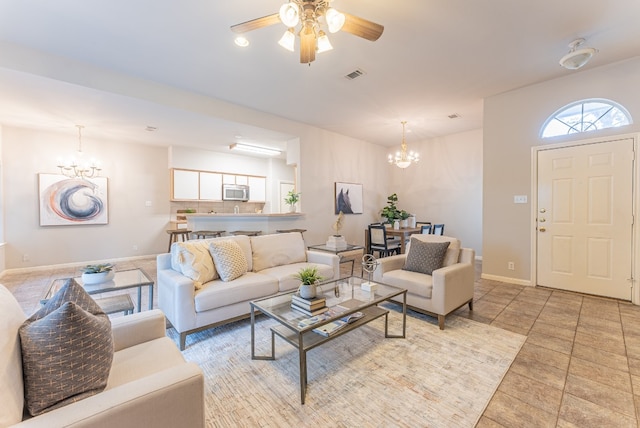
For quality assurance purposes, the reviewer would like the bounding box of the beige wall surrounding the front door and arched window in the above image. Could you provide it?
[482,58,640,283]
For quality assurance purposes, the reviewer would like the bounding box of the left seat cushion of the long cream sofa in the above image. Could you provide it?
[195,272,278,313]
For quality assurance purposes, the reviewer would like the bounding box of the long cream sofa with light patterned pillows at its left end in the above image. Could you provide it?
[157,232,340,350]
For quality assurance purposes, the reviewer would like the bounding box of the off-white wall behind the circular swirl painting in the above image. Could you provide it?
[2,126,169,269]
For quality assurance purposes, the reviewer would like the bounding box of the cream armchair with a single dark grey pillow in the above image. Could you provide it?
[373,234,475,330]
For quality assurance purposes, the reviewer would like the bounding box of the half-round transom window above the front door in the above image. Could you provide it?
[541,99,633,138]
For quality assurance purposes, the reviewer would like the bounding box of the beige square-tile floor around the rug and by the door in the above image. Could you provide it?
[5,258,640,427]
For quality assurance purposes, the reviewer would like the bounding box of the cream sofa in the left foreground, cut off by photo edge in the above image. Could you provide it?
[0,285,204,428]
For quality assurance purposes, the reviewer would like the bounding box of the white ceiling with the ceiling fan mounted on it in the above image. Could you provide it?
[0,0,640,150]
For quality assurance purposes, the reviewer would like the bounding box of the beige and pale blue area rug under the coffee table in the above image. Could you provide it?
[168,306,525,428]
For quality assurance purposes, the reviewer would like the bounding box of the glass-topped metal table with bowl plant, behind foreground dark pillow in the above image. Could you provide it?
[40,268,153,312]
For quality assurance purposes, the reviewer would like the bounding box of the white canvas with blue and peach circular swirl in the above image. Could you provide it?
[38,173,109,226]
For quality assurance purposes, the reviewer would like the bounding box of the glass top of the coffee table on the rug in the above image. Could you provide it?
[251,276,405,332]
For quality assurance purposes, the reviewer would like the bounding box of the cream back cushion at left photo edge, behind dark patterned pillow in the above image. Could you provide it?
[0,285,27,427]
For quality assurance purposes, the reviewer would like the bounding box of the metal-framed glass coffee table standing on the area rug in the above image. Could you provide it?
[251,276,407,404]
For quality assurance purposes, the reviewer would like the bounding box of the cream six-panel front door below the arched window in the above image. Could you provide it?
[536,139,634,300]
